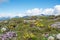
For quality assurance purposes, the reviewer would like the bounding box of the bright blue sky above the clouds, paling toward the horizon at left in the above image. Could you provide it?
[0,0,60,16]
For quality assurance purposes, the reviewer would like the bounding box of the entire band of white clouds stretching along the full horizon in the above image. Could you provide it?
[0,5,60,17]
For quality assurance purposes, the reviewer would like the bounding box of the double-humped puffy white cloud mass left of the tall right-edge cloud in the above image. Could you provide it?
[26,8,54,15]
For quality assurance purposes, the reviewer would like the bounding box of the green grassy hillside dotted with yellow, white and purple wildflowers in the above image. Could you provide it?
[0,15,60,40]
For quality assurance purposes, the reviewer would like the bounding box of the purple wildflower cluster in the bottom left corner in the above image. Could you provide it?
[0,32,17,40]
